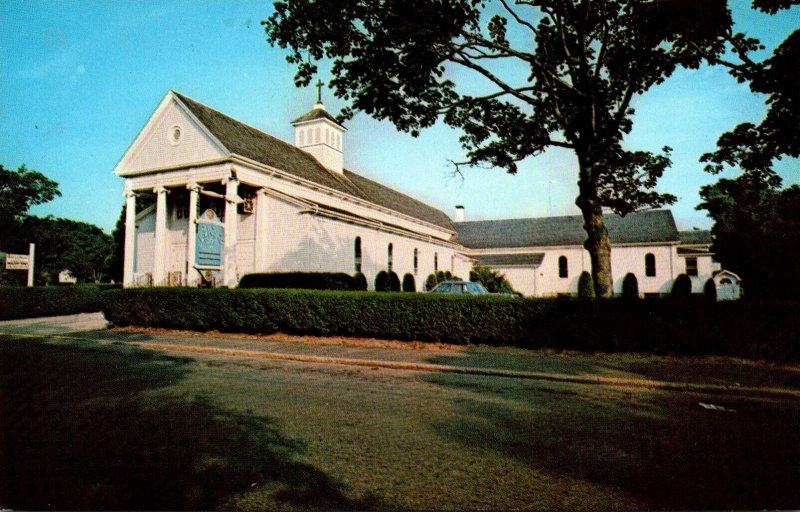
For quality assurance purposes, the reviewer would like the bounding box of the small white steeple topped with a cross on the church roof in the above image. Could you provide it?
[292,80,347,174]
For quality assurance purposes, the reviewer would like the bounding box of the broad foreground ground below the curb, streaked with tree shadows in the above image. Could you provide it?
[0,337,800,510]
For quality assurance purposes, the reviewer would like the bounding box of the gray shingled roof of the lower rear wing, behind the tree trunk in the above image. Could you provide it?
[455,210,679,249]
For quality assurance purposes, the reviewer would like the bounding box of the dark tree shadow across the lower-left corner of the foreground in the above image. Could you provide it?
[0,339,375,510]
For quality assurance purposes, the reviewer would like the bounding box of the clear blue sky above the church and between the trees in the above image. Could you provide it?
[0,0,800,232]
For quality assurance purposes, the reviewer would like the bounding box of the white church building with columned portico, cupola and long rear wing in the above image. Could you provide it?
[115,91,739,296]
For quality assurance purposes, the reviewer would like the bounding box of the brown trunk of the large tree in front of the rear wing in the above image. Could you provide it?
[575,165,614,298]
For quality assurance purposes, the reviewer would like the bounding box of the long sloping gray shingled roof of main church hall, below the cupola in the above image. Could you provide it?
[173,91,455,231]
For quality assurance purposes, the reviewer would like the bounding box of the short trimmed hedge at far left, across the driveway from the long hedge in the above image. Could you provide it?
[0,285,103,320]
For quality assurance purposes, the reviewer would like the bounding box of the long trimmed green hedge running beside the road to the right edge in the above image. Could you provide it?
[103,288,800,361]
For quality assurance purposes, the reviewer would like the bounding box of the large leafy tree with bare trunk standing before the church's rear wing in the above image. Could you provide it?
[263,0,748,297]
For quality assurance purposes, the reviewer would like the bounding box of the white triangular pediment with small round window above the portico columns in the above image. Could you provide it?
[114,91,229,176]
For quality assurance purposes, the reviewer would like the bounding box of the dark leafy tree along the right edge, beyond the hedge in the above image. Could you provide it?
[697,0,800,299]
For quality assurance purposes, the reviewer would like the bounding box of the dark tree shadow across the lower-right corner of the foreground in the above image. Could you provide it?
[425,374,800,510]
